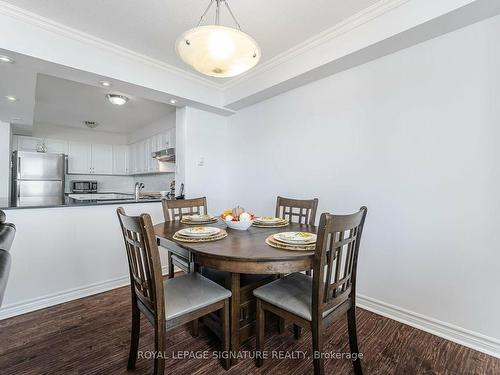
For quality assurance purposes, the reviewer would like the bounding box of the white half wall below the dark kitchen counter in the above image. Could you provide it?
[0,202,167,319]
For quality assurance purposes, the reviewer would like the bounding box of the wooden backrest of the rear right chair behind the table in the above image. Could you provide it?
[276,197,318,225]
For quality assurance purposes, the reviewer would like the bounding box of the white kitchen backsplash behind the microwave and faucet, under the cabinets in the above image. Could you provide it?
[65,173,175,193]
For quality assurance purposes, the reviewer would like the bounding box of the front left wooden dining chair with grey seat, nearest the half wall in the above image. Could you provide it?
[116,207,231,375]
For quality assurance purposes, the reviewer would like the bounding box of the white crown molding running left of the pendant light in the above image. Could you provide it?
[0,0,223,90]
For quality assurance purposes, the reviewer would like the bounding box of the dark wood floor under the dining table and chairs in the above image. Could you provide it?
[0,287,500,375]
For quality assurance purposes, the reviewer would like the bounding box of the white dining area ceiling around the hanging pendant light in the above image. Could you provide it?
[2,0,378,82]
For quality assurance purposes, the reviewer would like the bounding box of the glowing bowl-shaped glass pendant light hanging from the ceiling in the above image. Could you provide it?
[176,0,261,77]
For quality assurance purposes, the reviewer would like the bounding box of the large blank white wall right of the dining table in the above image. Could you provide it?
[227,17,500,355]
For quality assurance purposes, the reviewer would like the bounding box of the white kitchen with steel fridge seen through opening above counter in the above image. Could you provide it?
[0,74,183,208]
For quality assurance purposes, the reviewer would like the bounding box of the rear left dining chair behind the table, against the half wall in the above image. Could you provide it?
[161,197,208,278]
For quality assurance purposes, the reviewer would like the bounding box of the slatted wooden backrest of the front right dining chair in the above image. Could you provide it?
[312,207,368,317]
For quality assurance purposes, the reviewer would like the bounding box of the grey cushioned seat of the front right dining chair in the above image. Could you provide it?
[253,272,334,321]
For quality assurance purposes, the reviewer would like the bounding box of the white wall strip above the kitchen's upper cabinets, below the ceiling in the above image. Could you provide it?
[33,123,128,145]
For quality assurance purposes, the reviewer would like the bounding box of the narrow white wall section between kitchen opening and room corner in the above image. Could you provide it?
[176,107,228,215]
